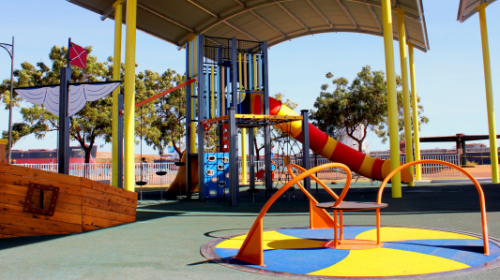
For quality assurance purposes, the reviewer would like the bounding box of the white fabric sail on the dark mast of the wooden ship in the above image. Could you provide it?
[16,82,120,117]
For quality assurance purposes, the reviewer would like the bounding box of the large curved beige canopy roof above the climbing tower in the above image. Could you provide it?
[67,0,429,52]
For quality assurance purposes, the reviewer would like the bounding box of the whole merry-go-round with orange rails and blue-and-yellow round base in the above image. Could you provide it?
[202,160,494,277]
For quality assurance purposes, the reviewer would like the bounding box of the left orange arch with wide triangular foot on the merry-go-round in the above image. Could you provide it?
[235,163,351,266]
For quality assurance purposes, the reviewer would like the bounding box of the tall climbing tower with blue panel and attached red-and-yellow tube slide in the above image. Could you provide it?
[162,35,413,205]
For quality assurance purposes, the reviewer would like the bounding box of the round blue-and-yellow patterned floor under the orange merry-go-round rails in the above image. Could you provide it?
[201,226,500,279]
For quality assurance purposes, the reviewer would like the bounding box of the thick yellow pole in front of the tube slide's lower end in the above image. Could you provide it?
[382,0,402,198]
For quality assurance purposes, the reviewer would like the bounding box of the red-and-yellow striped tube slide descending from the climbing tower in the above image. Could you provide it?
[250,94,413,183]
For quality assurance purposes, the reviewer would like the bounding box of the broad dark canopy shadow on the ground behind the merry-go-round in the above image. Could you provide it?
[138,183,500,215]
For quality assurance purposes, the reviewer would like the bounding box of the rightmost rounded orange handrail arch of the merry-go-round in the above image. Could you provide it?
[377,159,490,256]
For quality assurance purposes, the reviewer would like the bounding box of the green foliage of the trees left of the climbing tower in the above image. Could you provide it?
[0,46,185,162]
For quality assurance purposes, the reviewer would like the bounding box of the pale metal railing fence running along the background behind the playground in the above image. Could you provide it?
[16,155,461,185]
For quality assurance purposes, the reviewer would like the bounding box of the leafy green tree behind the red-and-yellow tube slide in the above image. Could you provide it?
[311,66,428,152]
